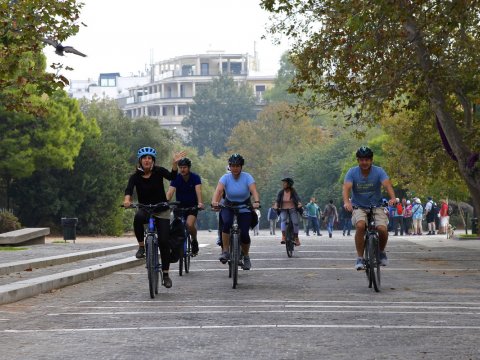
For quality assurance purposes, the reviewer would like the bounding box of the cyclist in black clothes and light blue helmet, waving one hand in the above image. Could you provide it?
[123,146,186,288]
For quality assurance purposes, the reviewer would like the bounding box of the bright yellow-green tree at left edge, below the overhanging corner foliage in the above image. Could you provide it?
[0,91,98,206]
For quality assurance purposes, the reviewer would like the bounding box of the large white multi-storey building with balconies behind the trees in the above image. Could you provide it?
[119,51,275,131]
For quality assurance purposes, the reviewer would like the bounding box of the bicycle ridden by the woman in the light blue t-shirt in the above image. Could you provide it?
[218,203,252,289]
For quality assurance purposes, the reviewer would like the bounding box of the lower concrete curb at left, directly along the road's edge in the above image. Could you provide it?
[0,256,145,305]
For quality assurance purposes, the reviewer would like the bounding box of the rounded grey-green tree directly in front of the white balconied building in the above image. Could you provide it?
[182,76,255,155]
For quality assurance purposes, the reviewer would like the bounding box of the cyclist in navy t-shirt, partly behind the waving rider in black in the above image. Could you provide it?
[167,158,204,256]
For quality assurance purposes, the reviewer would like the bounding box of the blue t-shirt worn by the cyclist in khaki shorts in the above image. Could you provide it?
[344,165,389,208]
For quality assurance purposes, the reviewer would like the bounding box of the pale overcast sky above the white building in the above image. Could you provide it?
[44,0,287,80]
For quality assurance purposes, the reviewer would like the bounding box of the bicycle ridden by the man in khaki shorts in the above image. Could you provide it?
[358,205,380,292]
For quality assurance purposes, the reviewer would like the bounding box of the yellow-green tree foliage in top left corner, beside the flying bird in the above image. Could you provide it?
[0,0,83,115]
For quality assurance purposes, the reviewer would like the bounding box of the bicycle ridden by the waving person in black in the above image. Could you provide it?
[122,202,178,299]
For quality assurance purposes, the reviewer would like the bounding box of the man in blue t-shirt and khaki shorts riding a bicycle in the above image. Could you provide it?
[343,146,395,270]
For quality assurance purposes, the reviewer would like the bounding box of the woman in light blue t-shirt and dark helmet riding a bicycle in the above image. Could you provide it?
[212,154,260,270]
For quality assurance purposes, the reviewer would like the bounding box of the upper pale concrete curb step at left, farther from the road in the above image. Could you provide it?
[0,244,138,275]
